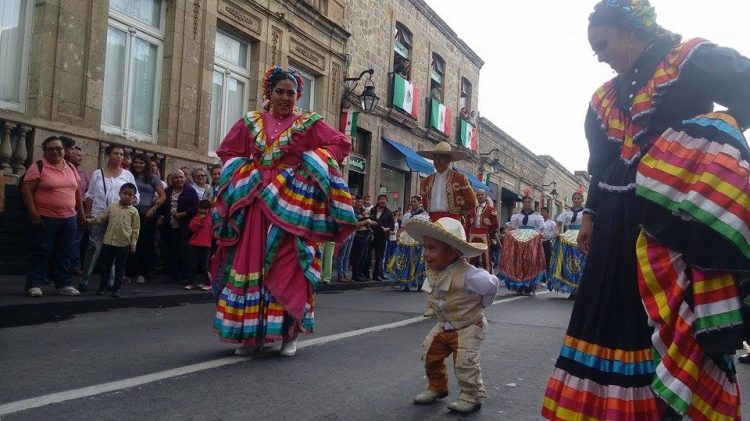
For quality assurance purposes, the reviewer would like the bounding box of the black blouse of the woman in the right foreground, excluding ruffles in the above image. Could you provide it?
[585,41,750,212]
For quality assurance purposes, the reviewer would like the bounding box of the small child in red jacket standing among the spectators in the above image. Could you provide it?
[185,199,211,291]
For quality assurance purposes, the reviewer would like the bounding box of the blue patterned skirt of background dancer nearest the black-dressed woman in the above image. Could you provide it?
[547,229,586,293]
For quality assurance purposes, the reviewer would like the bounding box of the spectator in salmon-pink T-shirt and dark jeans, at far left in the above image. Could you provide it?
[22,136,83,297]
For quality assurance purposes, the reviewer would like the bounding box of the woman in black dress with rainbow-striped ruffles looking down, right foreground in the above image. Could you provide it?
[542,0,750,421]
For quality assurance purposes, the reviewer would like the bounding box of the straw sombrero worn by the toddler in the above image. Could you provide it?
[406,217,487,257]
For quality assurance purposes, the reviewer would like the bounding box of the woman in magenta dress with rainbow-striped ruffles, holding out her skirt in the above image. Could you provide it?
[212,67,356,356]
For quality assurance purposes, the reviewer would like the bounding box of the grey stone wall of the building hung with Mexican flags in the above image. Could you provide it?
[343,0,483,210]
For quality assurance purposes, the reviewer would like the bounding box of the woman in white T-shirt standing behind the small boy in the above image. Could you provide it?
[78,145,140,291]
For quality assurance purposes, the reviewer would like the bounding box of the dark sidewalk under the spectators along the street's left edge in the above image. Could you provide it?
[0,275,390,328]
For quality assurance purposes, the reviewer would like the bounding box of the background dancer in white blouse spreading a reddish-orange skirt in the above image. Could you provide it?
[499,196,547,295]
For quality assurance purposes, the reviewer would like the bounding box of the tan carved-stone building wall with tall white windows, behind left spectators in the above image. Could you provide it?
[0,0,349,271]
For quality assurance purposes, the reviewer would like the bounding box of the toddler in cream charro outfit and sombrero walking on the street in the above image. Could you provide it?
[406,218,498,414]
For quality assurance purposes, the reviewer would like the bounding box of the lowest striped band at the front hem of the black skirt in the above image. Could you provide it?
[542,367,660,421]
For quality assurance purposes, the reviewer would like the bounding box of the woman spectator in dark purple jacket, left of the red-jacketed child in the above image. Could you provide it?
[159,170,200,285]
